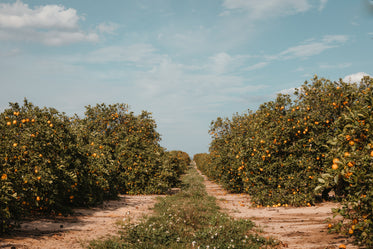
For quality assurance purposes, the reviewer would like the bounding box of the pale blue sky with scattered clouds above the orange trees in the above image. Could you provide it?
[0,0,373,156]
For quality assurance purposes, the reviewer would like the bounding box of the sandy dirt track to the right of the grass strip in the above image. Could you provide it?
[196,167,358,249]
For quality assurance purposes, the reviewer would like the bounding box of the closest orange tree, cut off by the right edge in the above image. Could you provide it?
[317,77,373,247]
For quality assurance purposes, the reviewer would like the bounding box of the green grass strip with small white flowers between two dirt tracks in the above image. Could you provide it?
[89,165,275,249]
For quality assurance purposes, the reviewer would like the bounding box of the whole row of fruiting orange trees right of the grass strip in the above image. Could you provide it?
[194,76,373,246]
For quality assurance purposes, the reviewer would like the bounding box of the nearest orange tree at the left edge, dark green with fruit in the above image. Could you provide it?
[0,100,84,231]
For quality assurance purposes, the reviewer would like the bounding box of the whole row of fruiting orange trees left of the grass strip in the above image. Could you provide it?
[0,100,190,233]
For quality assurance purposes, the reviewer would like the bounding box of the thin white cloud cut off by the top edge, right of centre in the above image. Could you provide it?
[222,0,312,19]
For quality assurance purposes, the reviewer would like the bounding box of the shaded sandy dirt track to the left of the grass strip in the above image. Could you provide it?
[0,195,156,249]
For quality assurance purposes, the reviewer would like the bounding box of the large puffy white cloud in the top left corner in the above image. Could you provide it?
[0,0,102,46]
